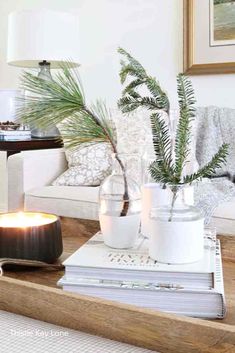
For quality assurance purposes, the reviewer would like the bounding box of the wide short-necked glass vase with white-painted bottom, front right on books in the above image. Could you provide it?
[149,185,204,264]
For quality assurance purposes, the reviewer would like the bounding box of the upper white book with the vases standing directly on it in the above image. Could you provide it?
[64,230,216,289]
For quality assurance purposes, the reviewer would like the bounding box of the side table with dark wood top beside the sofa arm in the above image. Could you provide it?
[0,138,63,212]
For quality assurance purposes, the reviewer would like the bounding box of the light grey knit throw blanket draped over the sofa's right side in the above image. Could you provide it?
[195,106,235,224]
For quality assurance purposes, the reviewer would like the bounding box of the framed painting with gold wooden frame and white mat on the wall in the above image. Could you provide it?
[184,0,235,75]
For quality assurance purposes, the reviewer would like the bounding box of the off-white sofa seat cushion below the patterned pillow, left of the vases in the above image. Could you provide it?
[25,186,99,220]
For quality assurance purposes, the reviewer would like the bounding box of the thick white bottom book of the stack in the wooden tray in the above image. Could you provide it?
[58,240,226,319]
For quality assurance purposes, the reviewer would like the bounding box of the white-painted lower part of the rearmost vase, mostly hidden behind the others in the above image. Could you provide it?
[141,183,194,238]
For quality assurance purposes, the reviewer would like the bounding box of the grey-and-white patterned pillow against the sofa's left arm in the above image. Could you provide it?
[52,143,112,186]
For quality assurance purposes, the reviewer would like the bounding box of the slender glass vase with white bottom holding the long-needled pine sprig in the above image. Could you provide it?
[99,154,141,249]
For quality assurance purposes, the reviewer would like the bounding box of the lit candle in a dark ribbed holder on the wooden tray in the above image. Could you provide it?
[0,212,63,263]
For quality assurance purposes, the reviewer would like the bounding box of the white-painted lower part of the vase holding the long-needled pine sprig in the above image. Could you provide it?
[99,213,140,249]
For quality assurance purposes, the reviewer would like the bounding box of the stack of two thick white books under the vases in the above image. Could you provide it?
[58,231,225,318]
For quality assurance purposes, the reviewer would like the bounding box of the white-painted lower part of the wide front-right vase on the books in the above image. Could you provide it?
[149,218,204,264]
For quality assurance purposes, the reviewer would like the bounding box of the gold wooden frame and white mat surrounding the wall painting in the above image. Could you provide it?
[183,0,235,75]
